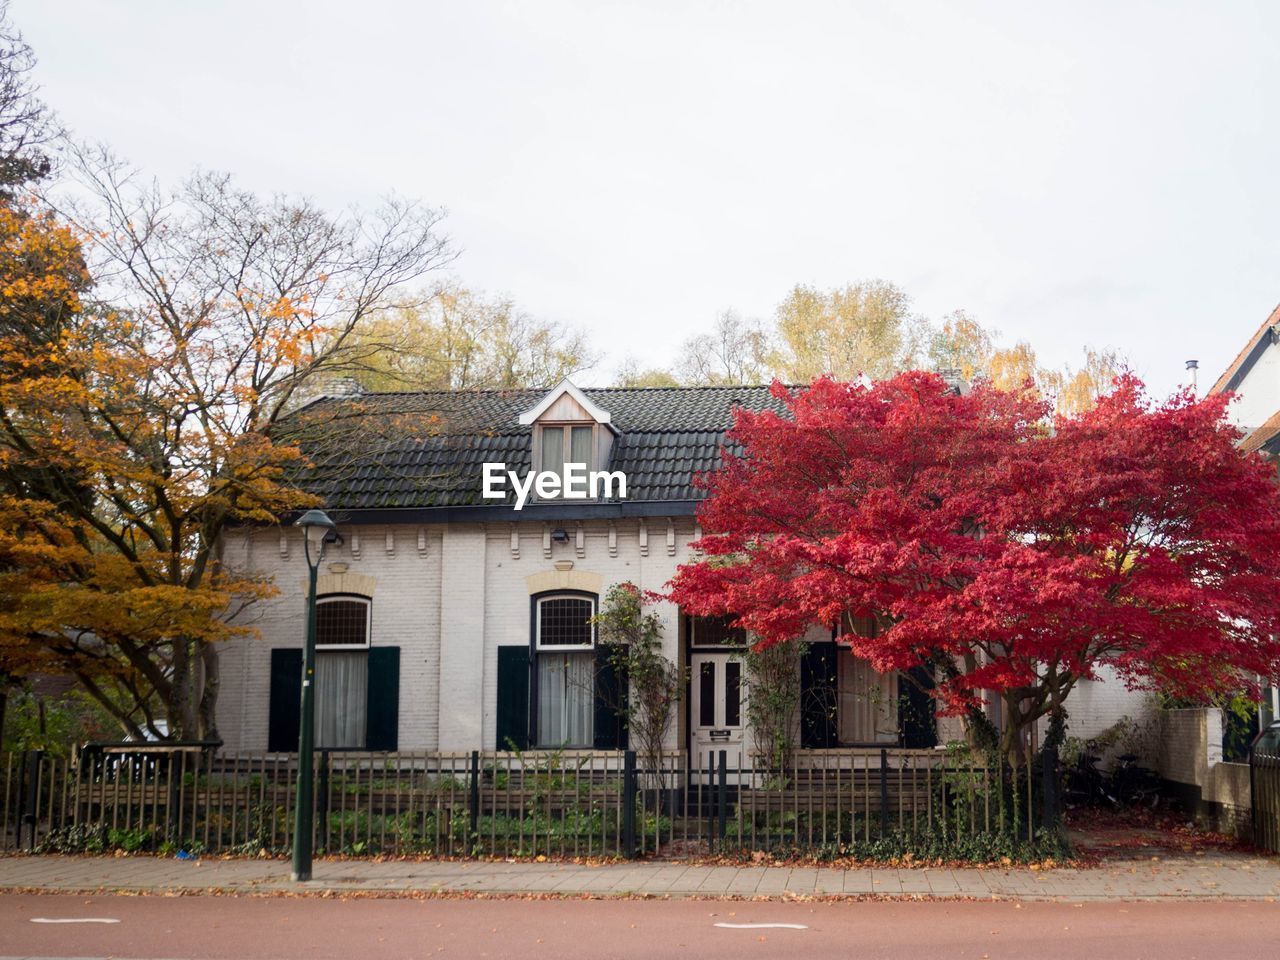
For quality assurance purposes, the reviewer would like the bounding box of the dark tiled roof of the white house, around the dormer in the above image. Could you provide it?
[293,387,785,509]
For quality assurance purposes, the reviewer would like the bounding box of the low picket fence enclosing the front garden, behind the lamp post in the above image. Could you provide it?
[0,745,1037,858]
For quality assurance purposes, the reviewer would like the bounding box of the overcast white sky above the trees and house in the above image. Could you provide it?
[20,0,1280,392]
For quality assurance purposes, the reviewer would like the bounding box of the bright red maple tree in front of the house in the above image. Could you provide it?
[669,372,1280,759]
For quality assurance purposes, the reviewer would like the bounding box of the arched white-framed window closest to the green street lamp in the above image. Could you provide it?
[315,595,371,750]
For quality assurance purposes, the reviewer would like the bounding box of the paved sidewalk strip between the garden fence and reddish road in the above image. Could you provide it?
[0,852,1280,901]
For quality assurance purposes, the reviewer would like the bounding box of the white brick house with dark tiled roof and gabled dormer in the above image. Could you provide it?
[218,381,1141,751]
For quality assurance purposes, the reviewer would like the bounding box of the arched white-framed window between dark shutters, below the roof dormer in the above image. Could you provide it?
[534,594,595,746]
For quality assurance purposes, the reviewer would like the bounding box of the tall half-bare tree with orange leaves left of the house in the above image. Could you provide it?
[0,152,451,739]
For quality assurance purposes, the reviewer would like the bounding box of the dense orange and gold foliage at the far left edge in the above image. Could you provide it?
[0,193,282,736]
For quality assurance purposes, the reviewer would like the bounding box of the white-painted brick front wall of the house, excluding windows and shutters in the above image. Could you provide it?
[218,517,1142,750]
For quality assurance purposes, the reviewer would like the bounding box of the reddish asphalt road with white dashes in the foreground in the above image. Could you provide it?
[0,895,1280,960]
